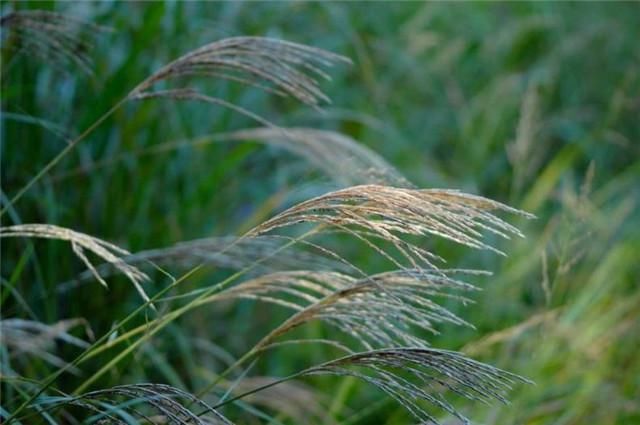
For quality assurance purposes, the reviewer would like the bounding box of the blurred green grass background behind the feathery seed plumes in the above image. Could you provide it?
[1,1,640,425]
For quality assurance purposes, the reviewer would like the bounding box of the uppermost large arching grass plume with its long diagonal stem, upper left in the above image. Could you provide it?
[0,37,350,217]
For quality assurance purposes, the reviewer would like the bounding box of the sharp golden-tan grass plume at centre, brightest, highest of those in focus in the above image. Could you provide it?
[252,185,533,262]
